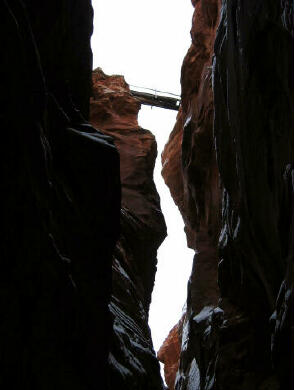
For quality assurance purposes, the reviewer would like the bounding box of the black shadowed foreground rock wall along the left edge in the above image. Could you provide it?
[0,0,120,390]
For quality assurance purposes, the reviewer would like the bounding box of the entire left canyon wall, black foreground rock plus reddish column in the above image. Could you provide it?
[0,0,166,390]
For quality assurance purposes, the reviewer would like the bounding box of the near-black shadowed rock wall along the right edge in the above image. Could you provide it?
[213,1,294,389]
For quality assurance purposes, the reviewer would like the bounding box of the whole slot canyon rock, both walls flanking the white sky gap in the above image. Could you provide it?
[0,0,294,390]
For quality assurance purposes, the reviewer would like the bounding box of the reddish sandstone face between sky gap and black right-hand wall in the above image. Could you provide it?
[162,0,221,389]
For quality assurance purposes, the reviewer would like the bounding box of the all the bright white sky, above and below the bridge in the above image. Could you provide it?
[92,0,193,351]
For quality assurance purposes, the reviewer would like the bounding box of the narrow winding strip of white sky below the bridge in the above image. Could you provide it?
[139,106,194,360]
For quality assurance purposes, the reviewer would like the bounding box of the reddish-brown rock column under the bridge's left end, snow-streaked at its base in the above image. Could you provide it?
[90,68,166,390]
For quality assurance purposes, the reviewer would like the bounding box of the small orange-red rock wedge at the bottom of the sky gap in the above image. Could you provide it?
[157,314,185,389]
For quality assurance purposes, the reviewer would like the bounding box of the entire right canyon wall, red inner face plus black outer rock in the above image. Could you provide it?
[160,0,294,390]
